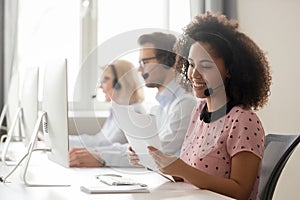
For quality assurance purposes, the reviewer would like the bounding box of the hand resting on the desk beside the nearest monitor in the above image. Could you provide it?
[69,148,104,167]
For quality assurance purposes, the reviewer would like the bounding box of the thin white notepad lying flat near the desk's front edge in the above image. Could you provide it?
[80,185,149,194]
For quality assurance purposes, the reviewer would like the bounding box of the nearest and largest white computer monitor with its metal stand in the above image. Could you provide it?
[22,59,69,186]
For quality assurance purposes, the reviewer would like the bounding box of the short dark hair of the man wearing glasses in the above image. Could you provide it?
[138,32,176,67]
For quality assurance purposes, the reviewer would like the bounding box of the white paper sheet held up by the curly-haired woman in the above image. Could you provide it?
[112,102,161,170]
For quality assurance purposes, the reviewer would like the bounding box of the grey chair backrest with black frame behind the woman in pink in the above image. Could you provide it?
[258,134,300,200]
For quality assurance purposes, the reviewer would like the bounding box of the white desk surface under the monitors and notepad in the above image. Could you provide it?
[0,141,231,200]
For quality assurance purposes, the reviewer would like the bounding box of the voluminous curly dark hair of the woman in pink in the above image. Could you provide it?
[174,12,272,110]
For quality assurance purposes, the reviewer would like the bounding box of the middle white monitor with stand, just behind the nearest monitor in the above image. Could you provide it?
[1,67,39,165]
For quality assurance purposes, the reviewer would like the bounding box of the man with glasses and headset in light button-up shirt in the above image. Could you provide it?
[128,32,196,161]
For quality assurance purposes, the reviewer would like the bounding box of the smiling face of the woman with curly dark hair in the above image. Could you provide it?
[188,42,227,98]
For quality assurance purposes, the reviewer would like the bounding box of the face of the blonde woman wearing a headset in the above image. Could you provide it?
[100,68,114,102]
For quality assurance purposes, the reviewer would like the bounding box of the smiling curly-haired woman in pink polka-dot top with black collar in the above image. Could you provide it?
[133,12,271,200]
